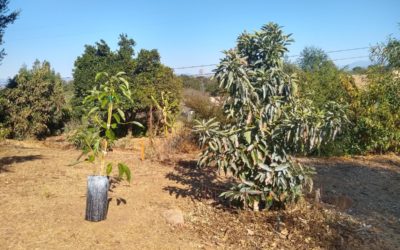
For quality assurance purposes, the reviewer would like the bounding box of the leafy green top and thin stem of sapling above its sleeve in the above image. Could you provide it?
[74,72,142,181]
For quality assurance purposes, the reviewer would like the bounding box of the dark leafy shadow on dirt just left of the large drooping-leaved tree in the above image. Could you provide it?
[164,160,233,204]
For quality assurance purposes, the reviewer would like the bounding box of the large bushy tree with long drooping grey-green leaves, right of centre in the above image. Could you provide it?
[194,23,346,210]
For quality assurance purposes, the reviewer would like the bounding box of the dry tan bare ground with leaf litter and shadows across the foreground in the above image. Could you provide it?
[0,141,400,249]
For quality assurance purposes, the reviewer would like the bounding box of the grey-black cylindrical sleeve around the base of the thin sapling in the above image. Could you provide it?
[85,175,109,221]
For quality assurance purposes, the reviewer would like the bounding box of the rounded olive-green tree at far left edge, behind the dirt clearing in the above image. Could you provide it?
[1,60,65,139]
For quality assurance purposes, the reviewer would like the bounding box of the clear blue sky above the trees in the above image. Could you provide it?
[0,0,400,78]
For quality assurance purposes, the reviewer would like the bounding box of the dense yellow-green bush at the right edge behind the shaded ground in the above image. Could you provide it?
[352,67,400,153]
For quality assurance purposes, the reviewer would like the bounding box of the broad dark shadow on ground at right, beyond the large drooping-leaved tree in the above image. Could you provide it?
[305,158,400,244]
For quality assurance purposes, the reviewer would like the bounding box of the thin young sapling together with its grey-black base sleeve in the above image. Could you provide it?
[75,72,142,221]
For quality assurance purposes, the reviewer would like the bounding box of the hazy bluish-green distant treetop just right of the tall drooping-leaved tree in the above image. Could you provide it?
[298,47,334,71]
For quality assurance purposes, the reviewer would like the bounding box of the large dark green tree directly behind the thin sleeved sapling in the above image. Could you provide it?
[72,34,182,135]
